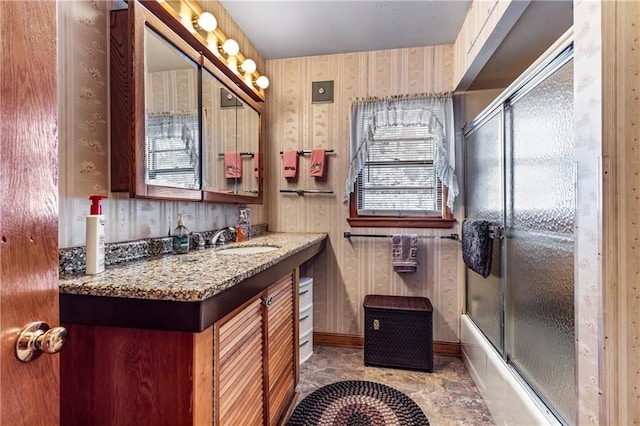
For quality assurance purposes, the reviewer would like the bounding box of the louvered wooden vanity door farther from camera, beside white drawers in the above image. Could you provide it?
[265,274,297,425]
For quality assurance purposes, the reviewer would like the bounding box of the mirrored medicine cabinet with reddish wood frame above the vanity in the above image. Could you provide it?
[111,1,262,204]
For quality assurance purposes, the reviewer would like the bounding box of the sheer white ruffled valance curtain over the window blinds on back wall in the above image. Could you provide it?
[346,93,458,209]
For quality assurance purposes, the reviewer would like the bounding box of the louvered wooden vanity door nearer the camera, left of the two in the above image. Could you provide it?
[214,298,265,426]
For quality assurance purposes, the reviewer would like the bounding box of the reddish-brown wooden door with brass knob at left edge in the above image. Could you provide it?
[0,1,60,426]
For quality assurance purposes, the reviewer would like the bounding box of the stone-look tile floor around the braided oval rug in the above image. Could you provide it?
[297,346,495,426]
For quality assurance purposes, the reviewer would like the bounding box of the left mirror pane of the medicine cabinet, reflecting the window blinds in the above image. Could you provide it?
[144,27,201,189]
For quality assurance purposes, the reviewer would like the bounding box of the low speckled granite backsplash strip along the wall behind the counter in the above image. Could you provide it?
[58,223,268,275]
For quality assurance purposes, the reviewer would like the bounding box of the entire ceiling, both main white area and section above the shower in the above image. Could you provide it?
[220,0,573,90]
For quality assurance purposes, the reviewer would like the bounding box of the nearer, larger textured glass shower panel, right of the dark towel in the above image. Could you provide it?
[505,58,575,423]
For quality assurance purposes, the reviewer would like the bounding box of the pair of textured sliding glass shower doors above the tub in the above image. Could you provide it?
[464,47,576,424]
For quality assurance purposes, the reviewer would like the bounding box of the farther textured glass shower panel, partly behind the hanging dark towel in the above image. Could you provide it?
[465,110,503,352]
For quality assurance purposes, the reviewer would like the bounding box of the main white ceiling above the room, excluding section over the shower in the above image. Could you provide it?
[221,0,471,60]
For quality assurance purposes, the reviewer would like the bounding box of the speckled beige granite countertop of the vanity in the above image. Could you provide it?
[60,233,327,302]
